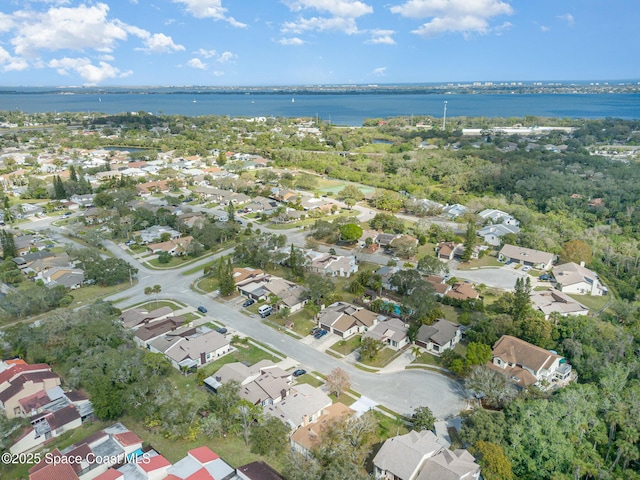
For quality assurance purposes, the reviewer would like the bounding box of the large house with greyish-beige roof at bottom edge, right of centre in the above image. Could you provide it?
[373,430,480,480]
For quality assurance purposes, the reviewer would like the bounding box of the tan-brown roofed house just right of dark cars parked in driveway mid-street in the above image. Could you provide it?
[318,302,387,338]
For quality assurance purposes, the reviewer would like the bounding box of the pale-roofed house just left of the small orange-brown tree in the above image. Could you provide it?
[264,383,333,432]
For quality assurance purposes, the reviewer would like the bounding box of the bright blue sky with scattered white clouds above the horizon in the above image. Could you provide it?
[0,0,640,86]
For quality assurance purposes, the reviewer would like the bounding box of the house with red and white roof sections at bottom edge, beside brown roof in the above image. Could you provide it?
[166,447,235,480]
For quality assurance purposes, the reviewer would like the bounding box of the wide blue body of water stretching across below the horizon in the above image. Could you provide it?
[0,88,640,125]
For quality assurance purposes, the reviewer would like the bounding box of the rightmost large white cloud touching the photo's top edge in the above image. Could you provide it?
[391,0,513,36]
